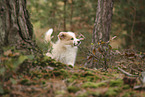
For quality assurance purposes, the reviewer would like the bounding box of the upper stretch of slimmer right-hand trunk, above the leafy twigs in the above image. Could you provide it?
[92,0,113,43]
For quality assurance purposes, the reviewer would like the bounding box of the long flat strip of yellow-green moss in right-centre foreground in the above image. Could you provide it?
[82,82,107,88]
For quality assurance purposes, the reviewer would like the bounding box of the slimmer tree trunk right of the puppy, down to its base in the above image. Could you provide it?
[85,0,113,67]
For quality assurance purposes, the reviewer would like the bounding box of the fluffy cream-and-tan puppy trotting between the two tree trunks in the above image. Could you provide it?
[45,29,81,66]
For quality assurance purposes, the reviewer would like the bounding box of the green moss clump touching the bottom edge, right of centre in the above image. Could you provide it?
[105,88,121,97]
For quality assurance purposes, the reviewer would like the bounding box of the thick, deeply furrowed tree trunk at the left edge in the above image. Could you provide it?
[0,0,42,55]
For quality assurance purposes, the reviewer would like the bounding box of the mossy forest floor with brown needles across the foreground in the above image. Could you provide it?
[0,50,145,97]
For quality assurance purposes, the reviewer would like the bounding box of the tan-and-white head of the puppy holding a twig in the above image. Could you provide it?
[58,32,81,46]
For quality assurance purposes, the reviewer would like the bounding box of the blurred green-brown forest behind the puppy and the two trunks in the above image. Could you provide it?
[27,0,145,63]
